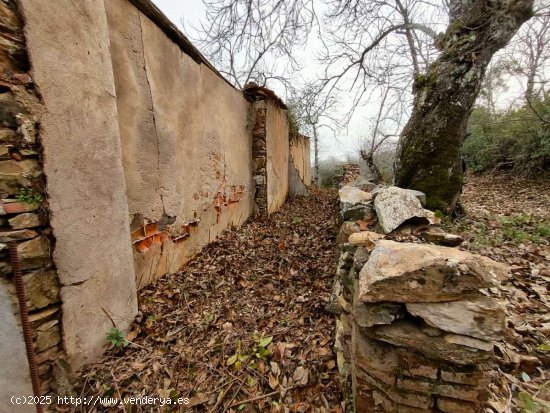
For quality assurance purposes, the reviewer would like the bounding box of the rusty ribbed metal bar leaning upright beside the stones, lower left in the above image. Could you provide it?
[9,241,44,413]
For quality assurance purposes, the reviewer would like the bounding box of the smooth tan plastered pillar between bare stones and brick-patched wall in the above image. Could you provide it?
[21,0,137,369]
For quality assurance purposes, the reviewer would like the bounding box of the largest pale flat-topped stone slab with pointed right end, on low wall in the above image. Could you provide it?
[359,240,508,303]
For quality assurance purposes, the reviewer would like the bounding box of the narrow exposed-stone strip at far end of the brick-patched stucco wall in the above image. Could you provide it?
[252,100,267,216]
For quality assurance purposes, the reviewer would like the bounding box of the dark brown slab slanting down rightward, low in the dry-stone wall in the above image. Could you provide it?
[368,320,492,366]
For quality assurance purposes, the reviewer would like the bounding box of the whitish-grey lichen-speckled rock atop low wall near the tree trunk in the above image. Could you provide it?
[374,186,429,234]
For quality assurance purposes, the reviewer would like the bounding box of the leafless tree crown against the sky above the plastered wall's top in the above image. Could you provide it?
[190,0,317,89]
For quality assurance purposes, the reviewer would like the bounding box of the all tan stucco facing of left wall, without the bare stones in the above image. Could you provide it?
[7,0,289,376]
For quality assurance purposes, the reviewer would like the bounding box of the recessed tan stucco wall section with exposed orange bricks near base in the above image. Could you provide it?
[106,0,253,286]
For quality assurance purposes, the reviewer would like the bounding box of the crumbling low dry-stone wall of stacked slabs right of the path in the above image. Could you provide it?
[327,186,508,413]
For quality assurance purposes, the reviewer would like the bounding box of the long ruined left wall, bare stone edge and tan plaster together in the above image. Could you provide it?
[0,0,289,388]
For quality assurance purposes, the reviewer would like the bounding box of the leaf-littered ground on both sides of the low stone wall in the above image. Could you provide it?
[60,174,550,413]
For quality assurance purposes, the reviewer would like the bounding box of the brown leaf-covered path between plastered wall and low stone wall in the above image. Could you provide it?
[68,191,346,412]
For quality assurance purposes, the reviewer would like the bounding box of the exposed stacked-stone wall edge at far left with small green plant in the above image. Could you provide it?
[0,1,61,394]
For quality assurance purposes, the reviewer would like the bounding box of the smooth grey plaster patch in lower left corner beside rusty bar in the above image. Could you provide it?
[0,280,35,413]
